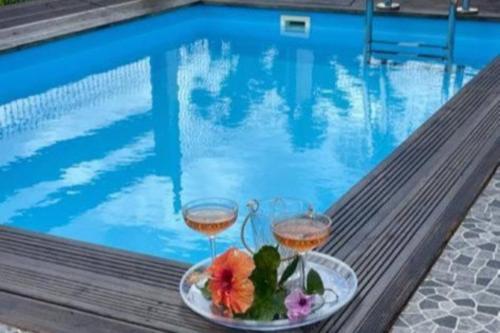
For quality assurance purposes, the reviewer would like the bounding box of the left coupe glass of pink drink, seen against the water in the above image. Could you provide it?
[182,198,238,262]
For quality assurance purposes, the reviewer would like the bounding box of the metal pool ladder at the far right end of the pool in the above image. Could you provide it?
[364,0,457,68]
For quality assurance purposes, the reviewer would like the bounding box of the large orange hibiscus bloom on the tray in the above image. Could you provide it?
[208,249,255,315]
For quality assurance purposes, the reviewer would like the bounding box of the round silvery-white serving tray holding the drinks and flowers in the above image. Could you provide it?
[180,251,358,331]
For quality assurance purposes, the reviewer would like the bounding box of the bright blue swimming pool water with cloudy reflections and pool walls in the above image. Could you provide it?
[0,6,500,262]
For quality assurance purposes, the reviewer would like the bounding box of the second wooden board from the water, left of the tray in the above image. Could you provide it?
[0,255,222,332]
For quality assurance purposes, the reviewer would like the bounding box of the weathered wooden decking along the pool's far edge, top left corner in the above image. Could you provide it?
[0,0,200,52]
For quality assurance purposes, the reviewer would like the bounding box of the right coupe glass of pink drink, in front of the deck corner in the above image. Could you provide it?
[272,211,332,289]
